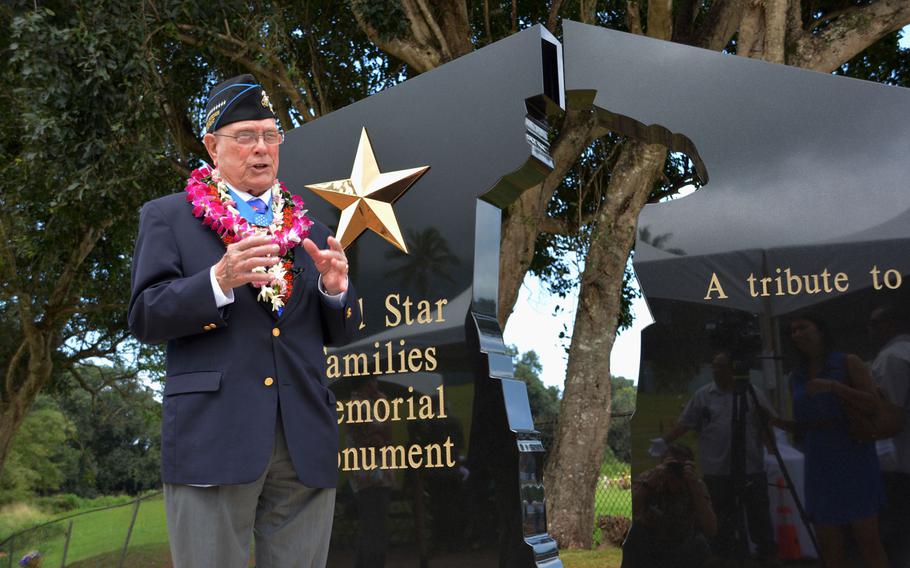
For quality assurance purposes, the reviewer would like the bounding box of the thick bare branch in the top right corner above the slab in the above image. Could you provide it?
[787,0,910,73]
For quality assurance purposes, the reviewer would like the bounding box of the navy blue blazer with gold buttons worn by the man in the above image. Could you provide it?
[129,193,359,487]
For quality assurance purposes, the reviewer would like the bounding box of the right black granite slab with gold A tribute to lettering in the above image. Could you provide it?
[552,20,910,568]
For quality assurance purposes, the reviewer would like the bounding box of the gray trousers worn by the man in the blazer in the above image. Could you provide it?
[164,418,335,568]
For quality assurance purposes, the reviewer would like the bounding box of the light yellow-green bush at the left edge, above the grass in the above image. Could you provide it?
[0,397,73,504]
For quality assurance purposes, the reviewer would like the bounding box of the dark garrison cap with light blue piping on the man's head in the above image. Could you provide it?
[205,74,277,132]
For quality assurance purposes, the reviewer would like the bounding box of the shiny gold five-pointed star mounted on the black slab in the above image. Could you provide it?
[306,128,430,253]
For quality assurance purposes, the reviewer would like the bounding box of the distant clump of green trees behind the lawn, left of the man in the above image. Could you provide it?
[0,366,161,502]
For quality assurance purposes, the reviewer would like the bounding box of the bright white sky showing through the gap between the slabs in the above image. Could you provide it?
[503,26,910,390]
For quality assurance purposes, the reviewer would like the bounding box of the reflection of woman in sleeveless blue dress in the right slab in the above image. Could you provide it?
[779,316,888,568]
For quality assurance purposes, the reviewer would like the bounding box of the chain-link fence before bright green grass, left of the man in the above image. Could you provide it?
[0,491,170,568]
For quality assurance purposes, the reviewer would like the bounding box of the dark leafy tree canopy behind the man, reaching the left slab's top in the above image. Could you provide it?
[0,0,402,484]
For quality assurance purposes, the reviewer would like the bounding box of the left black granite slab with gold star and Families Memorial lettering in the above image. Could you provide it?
[282,23,564,568]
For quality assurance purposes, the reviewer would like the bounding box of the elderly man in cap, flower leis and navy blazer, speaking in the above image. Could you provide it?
[129,75,359,568]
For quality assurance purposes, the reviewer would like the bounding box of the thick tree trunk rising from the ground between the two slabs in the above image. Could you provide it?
[544,141,667,548]
